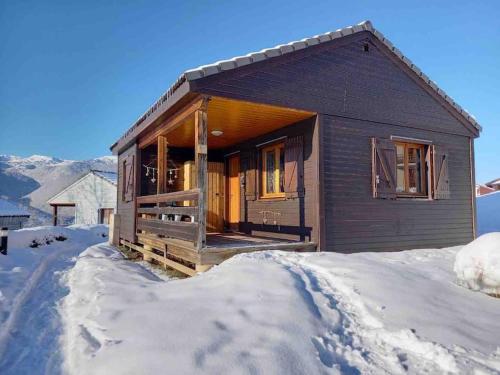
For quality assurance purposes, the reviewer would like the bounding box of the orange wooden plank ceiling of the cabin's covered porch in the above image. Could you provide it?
[165,97,315,149]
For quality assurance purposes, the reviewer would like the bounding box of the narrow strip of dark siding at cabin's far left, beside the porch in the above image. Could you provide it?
[116,144,140,242]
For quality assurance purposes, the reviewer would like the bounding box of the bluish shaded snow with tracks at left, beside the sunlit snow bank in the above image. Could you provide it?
[0,225,108,375]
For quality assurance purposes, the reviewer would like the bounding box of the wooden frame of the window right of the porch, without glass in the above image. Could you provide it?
[393,140,430,198]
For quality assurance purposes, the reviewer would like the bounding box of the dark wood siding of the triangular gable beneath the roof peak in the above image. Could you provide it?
[191,33,471,136]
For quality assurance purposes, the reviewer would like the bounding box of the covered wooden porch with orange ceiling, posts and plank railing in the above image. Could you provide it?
[121,96,316,275]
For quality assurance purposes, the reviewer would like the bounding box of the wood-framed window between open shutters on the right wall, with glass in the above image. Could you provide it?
[395,142,427,196]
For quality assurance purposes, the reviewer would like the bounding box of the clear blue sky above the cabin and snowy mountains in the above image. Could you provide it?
[0,0,500,182]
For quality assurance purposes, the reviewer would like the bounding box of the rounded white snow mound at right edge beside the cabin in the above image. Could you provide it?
[454,232,500,295]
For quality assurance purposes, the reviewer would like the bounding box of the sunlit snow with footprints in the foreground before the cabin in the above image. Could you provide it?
[60,244,500,374]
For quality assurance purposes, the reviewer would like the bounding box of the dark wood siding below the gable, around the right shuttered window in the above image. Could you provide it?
[320,115,473,252]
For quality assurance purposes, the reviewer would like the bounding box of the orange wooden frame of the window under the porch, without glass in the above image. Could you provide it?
[259,140,286,199]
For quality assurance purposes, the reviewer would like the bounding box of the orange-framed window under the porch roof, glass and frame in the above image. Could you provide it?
[261,142,285,198]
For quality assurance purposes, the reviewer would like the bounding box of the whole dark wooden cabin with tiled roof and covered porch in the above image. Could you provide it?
[111,21,481,274]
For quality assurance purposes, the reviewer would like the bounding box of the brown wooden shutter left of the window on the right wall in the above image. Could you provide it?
[372,138,396,199]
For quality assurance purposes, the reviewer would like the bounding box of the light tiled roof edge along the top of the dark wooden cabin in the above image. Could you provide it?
[111,21,482,153]
